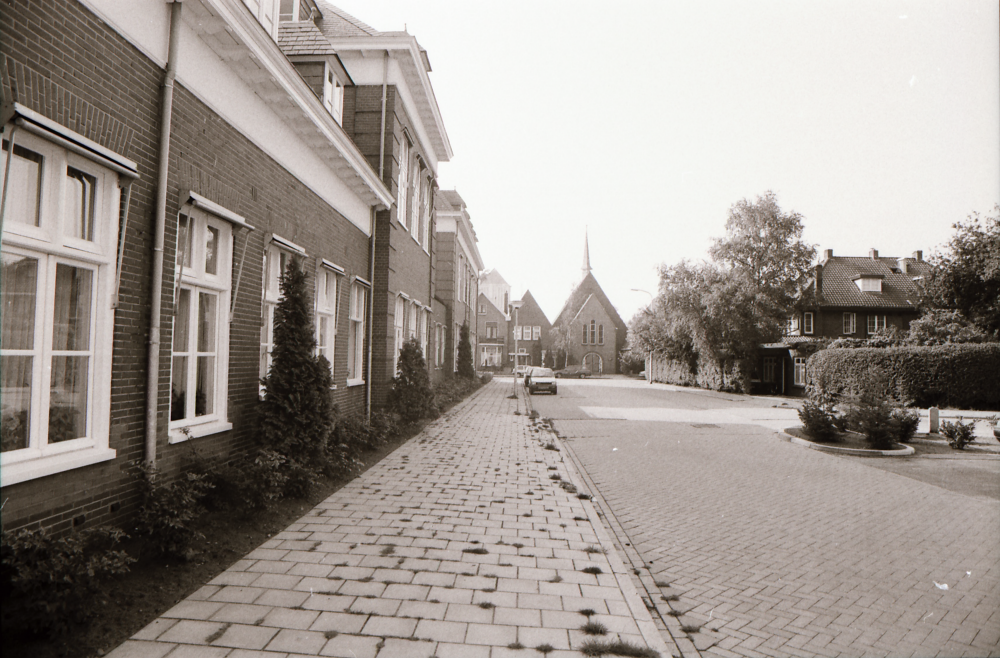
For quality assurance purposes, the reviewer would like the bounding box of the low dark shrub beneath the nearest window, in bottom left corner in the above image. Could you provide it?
[0,528,135,633]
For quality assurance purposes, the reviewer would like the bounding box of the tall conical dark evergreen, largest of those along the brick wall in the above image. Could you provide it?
[259,258,336,471]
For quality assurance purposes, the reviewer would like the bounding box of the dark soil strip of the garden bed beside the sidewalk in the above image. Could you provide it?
[2,412,442,658]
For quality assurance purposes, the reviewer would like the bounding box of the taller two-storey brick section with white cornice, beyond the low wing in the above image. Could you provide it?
[314,0,452,407]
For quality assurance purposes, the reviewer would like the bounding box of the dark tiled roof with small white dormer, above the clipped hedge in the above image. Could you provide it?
[817,256,930,308]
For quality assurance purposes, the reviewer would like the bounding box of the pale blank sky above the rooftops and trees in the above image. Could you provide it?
[333,0,1000,322]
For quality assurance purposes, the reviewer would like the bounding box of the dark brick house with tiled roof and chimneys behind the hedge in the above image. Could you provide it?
[752,249,930,395]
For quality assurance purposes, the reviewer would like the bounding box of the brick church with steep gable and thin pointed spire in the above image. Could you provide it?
[549,234,628,375]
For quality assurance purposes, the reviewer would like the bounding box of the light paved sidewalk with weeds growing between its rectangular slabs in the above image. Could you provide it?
[109,379,680,658]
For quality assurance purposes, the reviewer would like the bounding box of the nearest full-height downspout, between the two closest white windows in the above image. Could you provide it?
[145,0,182,464]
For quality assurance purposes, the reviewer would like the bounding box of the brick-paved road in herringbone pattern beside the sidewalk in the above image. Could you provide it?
[534,382,1000,656]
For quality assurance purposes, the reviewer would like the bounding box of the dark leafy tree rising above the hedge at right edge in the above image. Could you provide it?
[923,204,1000,336]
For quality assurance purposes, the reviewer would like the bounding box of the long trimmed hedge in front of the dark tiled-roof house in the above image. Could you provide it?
[808,343,1000,409]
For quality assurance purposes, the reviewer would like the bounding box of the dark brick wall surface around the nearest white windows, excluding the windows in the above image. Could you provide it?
[0,0,378,531]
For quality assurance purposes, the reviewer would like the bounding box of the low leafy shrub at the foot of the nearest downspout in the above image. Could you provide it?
[134,462,215,557]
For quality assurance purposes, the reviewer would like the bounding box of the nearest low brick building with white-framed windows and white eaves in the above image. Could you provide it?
[0,0,394,530]
